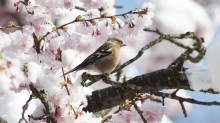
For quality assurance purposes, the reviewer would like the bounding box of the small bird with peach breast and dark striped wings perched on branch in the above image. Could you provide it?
[63,38,126,76]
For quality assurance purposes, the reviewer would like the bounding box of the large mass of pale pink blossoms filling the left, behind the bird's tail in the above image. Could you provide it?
[0,0,164,123]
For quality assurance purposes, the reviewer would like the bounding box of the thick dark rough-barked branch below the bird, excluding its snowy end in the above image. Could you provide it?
[84,55,190,112]
